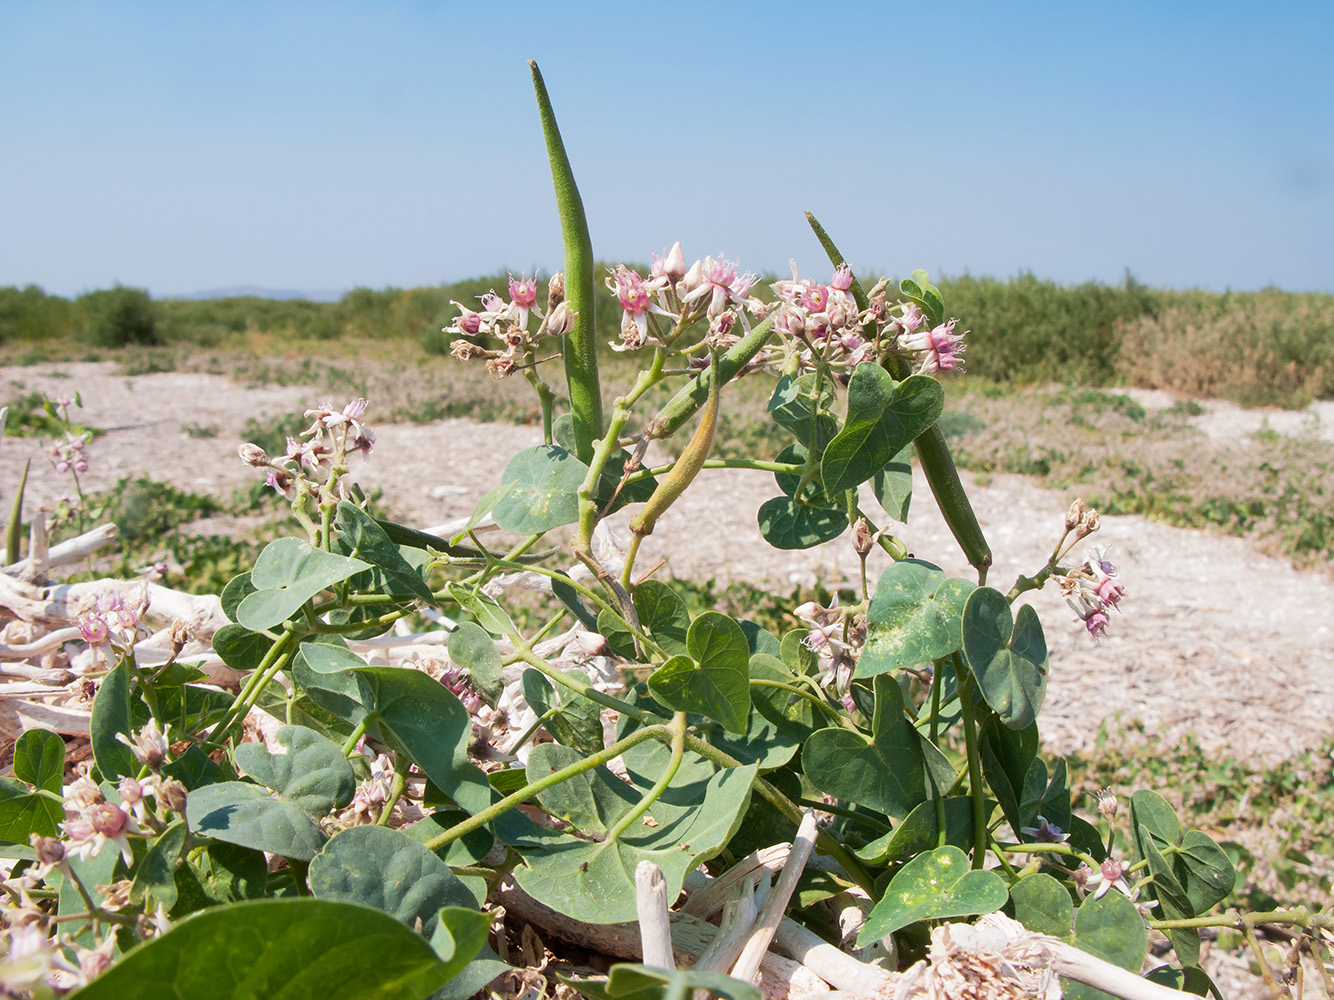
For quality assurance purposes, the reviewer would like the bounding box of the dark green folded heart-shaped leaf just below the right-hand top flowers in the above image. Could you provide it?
[820,361,944,496]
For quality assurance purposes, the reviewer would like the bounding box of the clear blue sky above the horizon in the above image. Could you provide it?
[0,0,1334,296]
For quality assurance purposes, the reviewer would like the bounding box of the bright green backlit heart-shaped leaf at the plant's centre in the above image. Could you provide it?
[648,611,750,735]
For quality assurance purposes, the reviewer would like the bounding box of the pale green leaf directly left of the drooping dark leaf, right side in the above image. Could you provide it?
[855,559,976,677]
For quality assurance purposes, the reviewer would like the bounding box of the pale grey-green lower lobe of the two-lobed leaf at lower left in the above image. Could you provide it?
[185,781,325,861]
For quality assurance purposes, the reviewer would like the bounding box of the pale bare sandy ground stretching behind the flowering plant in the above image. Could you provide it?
[0,364,1334,760]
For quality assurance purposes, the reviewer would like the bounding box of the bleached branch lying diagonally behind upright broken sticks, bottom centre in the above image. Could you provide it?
[492,885,828,1000]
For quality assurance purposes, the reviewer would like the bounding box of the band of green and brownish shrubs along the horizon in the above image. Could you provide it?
[0,275,1334,407]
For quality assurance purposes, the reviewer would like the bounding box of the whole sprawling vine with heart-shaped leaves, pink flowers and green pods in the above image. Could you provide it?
[0,60,1330,1000]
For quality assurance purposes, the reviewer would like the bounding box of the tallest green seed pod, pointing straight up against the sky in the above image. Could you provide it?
[528,60,603,464]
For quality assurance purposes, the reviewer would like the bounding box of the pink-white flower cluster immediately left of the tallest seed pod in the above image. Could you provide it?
[444,273,575,379]
